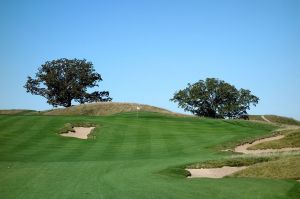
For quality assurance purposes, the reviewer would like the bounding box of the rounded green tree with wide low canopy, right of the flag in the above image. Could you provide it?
[171,78,259,118]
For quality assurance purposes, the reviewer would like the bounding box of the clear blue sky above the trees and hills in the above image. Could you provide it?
[0,0,300,119]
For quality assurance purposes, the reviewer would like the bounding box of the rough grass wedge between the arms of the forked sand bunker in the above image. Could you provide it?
[249,129,300,150]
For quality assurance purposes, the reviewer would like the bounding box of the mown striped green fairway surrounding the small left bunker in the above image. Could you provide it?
[0,113,300,199]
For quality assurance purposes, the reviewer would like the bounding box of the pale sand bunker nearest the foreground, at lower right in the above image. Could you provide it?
[187,166,247,178]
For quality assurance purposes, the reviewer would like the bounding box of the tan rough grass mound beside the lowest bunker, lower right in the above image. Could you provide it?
[232,156,300,180]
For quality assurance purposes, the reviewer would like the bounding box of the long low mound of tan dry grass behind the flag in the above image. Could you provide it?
[44,102,188,116]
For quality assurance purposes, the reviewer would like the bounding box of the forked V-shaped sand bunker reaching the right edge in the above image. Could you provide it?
[234,135,300,154]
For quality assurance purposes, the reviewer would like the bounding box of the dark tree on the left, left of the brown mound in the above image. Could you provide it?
[24,58,112,107]
